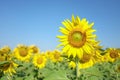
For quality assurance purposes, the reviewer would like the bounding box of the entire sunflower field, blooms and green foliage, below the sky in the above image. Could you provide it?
[0,15,120,80]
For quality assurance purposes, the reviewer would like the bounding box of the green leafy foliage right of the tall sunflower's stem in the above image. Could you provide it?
[80,60,120,80]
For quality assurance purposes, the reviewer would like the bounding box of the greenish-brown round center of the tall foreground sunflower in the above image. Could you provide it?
[68,28,86,48]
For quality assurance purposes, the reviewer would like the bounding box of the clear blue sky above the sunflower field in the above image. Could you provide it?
[0,0,120,51]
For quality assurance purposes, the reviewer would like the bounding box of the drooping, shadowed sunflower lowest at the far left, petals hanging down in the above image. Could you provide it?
[2,61,18,75]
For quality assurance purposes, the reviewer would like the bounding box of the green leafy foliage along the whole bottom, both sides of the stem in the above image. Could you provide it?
[0,60,120,80]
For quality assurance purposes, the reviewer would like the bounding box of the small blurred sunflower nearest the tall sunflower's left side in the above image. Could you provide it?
[50,50,63,62]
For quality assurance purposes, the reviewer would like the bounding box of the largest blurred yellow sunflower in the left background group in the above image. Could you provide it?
[13,45,31,61]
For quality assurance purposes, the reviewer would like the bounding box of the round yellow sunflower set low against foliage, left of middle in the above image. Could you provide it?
[33,54,47,69]
